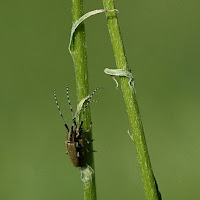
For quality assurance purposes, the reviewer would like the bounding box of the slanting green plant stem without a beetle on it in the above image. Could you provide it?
[103,0,159,200]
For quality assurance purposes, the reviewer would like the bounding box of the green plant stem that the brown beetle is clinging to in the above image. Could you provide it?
[71,0,96,200]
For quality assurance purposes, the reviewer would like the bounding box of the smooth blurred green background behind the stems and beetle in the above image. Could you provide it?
[0,0,200,200]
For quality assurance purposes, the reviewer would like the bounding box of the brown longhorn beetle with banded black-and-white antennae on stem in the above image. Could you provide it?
[54,85,100,167]
